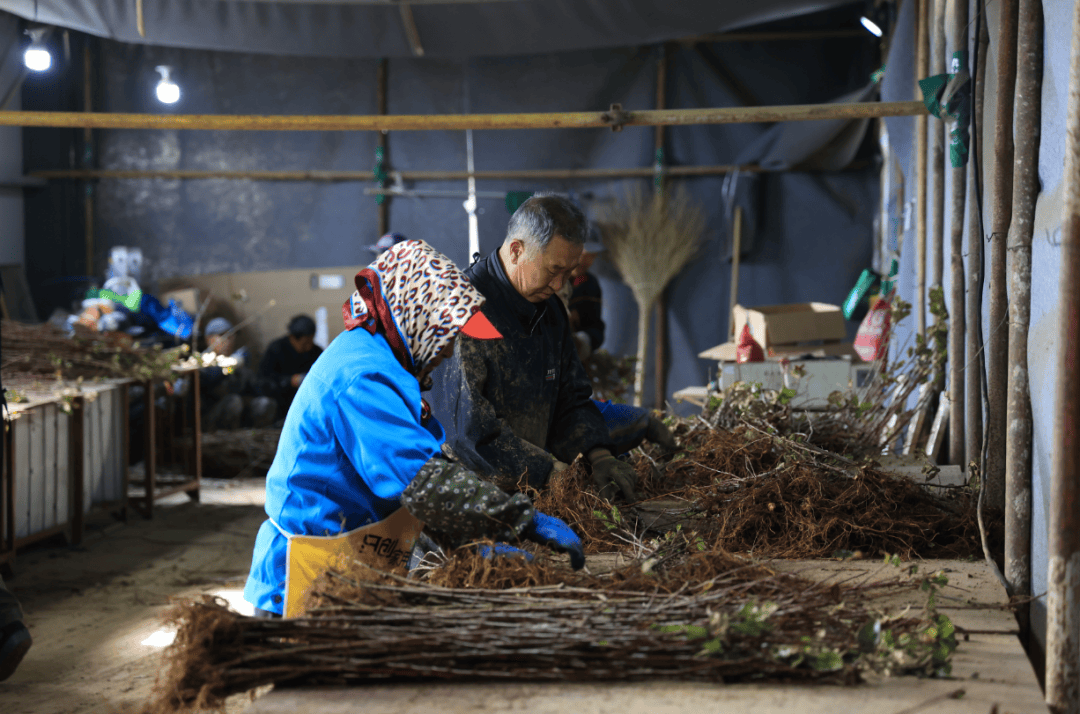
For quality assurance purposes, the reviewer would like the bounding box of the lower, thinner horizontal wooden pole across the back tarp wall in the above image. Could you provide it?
[30,164,765,181]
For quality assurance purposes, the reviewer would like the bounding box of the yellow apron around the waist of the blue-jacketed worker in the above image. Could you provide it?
[270,508,423,617]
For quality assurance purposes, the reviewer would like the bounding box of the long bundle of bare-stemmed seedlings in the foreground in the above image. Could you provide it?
[145,537,955,713]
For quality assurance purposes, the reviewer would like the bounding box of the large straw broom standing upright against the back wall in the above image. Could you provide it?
[596,186,705,406]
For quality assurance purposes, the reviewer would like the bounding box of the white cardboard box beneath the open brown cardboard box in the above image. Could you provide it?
[718,359,851,409]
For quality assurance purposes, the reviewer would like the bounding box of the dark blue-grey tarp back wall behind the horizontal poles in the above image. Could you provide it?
[12,8,877,412]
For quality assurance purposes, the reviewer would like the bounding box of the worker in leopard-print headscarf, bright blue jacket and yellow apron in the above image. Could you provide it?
[244,241,584,617]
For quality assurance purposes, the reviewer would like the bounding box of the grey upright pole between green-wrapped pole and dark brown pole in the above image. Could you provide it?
[964,0,990,474]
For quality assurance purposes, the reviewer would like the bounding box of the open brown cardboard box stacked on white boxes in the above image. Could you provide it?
[734,302,848,349]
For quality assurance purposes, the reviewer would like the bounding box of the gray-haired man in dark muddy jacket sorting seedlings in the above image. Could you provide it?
[433,193,637,501]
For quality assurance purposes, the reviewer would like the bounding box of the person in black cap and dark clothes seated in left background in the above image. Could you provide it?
[199,318,278,431]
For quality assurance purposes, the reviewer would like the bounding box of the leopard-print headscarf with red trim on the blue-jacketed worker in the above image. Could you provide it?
[341,240,485,375]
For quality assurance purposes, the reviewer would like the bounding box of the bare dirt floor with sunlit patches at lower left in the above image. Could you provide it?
[0,480,265,714]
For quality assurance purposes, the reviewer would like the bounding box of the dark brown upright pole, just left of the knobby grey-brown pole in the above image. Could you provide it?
[986,0,1018,511]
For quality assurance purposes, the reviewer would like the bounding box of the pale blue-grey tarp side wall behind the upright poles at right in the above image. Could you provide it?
[882,2,1075,669]
